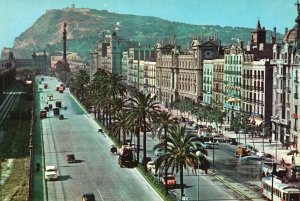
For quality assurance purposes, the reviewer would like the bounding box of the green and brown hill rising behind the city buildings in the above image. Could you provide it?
[13,8,282,59]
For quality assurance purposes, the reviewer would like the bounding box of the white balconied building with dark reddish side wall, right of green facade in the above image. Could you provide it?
[241,58,274,126]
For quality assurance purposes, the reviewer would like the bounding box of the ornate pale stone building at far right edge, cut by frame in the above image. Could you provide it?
[272,2,300,149]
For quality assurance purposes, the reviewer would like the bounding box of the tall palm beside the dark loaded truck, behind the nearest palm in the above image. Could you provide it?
[127,92,159,171]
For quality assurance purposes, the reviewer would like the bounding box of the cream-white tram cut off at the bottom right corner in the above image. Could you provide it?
[261,176,300,201]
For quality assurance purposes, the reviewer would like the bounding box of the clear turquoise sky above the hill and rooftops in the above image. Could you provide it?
[0,0,297,51]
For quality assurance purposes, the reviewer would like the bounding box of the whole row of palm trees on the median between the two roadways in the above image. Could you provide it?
[67,69,209,198]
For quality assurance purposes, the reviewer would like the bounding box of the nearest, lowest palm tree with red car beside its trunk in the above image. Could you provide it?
[153,125,207,196]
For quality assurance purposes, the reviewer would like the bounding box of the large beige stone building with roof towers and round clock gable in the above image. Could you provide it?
[156,36,220,106]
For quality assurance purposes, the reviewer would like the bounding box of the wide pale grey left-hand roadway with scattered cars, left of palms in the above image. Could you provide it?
[37,77,161,201]
